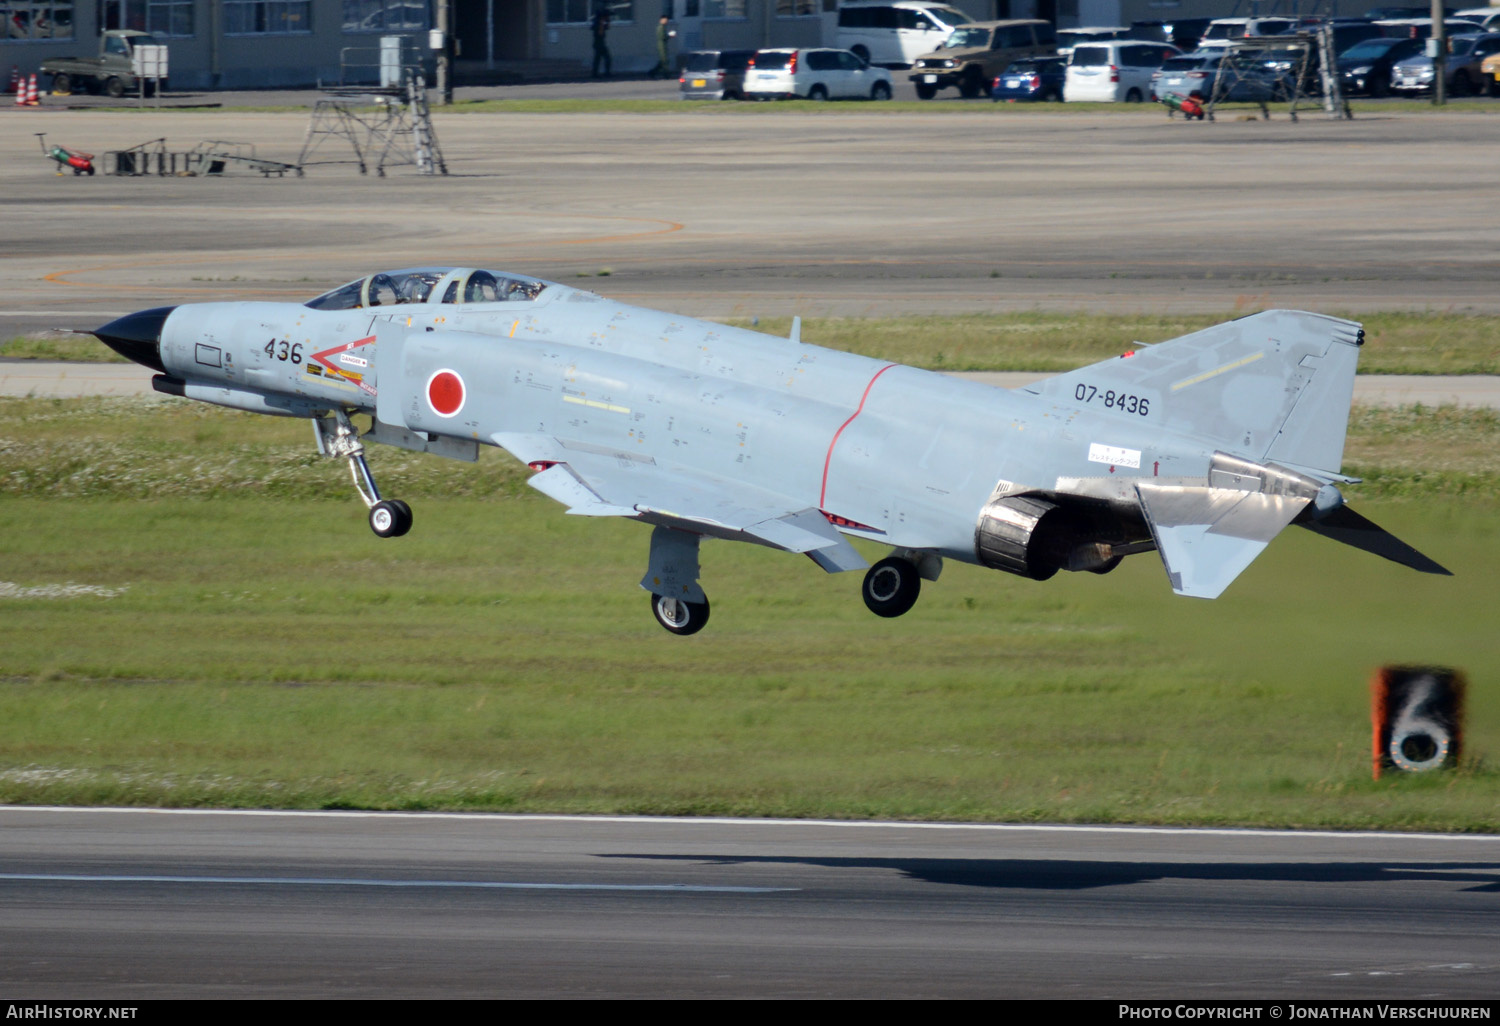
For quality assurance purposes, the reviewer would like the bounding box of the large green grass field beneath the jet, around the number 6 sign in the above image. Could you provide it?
[0,399,1500,831]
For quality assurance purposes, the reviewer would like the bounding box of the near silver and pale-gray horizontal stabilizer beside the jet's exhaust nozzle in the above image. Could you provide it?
[1136,485,1308,599]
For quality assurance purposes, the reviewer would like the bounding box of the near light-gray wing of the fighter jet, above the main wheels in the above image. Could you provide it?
[494,434,869,573]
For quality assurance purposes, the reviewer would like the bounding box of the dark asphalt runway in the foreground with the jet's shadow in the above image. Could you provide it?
[0,807,1500,1001]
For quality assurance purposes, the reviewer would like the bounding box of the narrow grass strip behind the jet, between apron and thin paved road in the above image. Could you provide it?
[0,312,1500,374]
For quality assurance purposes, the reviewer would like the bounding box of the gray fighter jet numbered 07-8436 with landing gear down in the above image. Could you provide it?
[95,267,1448,635]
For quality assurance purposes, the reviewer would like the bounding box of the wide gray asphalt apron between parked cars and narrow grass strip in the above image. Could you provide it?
[0,104,1500,338]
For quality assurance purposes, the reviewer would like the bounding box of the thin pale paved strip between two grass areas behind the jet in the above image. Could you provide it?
[0,360,1500,408]
